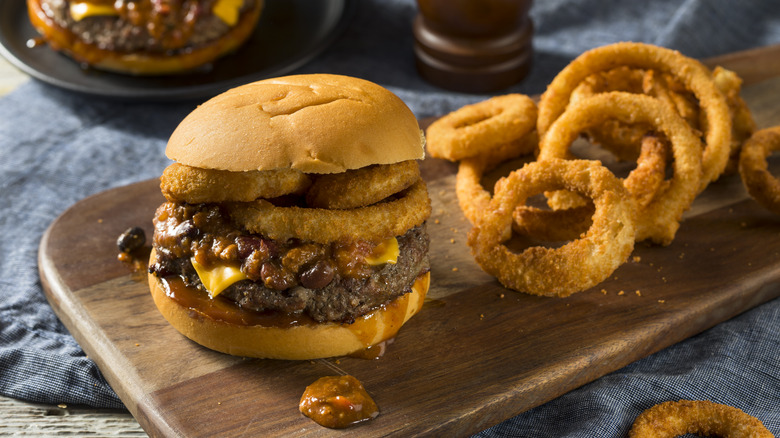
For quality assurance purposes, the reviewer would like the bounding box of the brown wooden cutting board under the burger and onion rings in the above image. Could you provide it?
[39,48,780,437]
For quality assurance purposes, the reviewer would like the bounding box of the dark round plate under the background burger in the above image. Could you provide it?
[0,0,355,101]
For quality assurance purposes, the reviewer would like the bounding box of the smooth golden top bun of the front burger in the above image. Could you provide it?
[166,74,424,173]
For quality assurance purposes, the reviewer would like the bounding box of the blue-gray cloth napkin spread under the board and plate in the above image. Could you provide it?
[0,0,780,437]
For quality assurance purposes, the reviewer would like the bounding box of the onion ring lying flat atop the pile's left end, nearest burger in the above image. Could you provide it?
[426,94,537,161]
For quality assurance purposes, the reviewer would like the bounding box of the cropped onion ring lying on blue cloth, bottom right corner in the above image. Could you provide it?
[628,400,774,438]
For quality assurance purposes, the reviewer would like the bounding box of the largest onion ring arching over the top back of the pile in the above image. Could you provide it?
[537,42,731,186]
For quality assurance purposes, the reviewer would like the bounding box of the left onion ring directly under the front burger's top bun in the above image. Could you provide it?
[160,163,311,204]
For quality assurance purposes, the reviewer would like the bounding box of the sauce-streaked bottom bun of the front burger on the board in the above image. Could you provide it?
[143,250,430,360]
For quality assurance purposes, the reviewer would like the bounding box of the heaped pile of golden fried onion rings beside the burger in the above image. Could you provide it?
[426,43,755,296]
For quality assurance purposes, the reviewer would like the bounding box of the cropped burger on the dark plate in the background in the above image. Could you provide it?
[27,0,263,75]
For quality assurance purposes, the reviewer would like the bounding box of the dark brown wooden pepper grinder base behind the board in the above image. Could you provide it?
[413,0,533,93]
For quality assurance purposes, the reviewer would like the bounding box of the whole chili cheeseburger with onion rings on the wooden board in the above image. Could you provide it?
[149,75,431,359]
